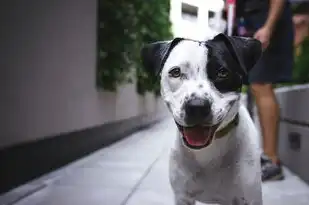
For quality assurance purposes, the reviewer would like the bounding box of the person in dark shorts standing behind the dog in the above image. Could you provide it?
[224,0,294,181]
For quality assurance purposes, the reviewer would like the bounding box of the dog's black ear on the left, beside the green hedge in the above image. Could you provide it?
[141,38,183,76]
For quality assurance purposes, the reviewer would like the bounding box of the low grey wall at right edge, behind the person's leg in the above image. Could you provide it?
[247,84,309,183]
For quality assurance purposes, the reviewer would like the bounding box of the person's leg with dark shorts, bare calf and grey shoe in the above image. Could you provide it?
[245,0,294,181]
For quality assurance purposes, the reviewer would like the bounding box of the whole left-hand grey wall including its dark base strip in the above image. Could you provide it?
[0,0,166,193]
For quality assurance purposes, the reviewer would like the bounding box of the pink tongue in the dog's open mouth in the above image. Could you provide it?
[183,126,213,146]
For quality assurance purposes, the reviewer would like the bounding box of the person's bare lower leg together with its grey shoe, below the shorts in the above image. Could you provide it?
[250,83,284,181]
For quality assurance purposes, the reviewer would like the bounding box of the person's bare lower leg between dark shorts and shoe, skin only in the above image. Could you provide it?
[251,83,279,163]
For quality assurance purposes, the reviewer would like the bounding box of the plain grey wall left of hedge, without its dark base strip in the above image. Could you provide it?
[0,0,164,148]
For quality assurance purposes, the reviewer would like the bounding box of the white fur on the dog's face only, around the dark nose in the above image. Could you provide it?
[161,40,240,129]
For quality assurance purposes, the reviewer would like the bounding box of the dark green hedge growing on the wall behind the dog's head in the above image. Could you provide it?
[97,0,172,94]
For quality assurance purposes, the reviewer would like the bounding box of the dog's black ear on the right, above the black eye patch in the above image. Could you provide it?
[209,33,262,81]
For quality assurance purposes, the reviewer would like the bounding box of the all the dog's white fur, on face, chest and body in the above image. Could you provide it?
[161,40,262,205]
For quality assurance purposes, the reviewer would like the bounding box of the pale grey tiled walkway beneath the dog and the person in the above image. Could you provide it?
[0,119,309,205]
